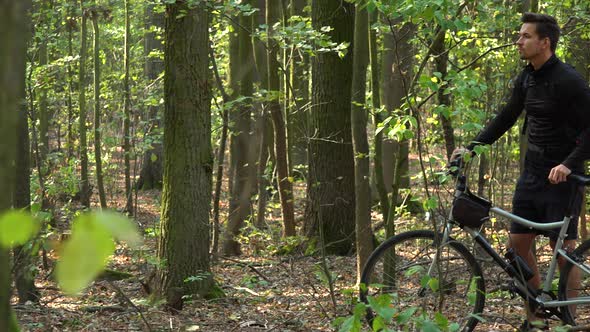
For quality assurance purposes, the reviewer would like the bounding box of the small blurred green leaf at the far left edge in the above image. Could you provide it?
[0,210,38,248]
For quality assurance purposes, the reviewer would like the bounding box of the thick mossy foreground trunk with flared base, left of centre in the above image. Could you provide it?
[157,2,213,310]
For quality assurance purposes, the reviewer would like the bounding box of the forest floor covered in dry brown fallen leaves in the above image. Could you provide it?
[12,176,572,331]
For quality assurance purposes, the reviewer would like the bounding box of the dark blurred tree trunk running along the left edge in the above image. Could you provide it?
[0,0,30,332]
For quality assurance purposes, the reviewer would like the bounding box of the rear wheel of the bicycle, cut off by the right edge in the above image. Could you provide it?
[558,240,590,331]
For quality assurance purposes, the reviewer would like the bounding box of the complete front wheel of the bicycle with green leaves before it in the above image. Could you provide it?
[360,230,485,331]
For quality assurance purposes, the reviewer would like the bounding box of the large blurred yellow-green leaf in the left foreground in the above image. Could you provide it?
[56,215,115,295]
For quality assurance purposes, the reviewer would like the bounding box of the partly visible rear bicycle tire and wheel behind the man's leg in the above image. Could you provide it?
[557,240,590,326]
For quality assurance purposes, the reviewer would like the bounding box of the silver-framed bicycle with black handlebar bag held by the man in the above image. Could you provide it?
[359,160,590,331]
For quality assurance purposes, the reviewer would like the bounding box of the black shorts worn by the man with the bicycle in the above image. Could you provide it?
[510,169,583,241]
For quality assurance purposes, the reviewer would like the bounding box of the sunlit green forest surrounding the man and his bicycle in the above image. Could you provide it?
[0,0,590,332]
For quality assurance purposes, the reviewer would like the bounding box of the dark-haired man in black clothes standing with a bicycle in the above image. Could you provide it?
[460,13,590,331]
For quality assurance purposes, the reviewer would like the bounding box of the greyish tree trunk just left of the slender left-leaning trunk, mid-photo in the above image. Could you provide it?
[223,1,254,255]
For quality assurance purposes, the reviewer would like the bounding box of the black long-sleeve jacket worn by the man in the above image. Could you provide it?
[469,55,590,170]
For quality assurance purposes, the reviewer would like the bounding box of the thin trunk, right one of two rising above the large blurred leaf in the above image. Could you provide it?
[91,11,107,209]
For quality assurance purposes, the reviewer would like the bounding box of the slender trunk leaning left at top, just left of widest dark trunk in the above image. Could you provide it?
[266,1,295,237]
